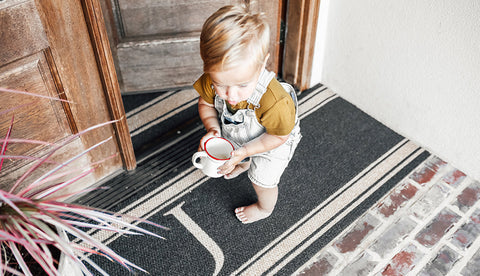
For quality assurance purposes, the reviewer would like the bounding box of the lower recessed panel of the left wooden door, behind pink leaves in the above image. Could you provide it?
[0,52,71,152]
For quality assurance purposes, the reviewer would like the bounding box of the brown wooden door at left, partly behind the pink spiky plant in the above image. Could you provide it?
[0,0,132,192]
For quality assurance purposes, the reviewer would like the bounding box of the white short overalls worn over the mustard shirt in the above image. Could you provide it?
[215,70,302,187]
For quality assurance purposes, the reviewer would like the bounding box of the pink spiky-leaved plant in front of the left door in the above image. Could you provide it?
[0,94,162,275]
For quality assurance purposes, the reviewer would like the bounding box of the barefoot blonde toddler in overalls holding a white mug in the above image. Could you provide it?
[193,6,301,223]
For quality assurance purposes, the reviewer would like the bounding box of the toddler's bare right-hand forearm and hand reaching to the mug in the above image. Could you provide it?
[219,133,290,174]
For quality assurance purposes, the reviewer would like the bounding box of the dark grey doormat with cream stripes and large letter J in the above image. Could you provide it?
[80,85,430,275]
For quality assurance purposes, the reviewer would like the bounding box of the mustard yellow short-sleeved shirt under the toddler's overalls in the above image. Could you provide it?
[193,73,295,136]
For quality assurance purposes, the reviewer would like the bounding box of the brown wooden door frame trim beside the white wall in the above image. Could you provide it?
[283,0,320,91]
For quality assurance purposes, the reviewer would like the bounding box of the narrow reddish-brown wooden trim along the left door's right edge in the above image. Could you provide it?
[81,0,137,170]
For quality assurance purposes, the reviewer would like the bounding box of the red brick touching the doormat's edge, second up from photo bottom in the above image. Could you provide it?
[333,215,379,253]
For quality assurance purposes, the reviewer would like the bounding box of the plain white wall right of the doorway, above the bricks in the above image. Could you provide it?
[312,0,480,180]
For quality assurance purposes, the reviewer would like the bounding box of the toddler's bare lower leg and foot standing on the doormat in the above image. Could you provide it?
[235,183,278,223]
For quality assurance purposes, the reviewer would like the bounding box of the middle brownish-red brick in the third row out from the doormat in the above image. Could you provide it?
[415,209,460,247]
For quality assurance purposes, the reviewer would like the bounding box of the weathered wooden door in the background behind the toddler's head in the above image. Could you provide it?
[101,0,283,93]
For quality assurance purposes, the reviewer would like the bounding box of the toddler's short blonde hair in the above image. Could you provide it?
[200,4,270,72]
